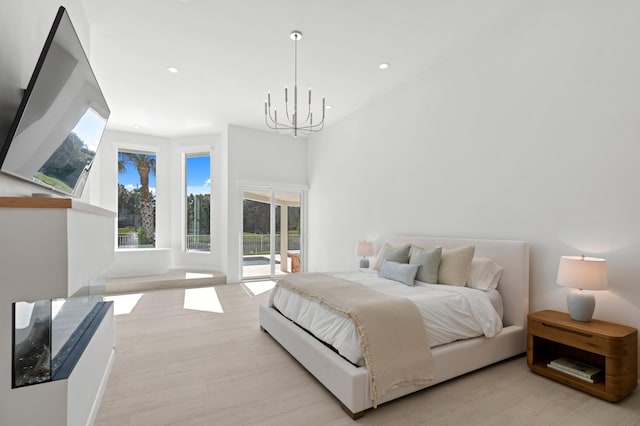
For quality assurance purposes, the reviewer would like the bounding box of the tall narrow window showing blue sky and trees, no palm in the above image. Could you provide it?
[185,154,211,252]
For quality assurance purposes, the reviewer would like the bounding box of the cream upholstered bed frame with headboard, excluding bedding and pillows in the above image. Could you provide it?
[259,235,529,418]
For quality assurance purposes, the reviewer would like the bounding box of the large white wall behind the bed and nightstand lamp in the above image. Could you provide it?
[309,0,640,356]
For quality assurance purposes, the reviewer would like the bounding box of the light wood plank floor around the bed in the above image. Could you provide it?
[95,284,640,426]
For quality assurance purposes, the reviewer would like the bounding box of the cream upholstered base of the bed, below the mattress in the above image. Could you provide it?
[260,305,526,419]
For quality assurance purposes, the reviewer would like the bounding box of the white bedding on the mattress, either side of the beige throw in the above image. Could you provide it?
[270,270,502,365]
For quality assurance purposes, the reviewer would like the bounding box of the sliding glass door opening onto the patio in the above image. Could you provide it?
[241,187,304,280]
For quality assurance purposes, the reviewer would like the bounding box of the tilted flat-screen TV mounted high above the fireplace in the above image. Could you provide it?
[0,7,111,197]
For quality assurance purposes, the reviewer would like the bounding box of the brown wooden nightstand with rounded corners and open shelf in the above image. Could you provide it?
[527,311,638,402]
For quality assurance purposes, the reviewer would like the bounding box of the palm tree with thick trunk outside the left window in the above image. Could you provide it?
[118,152,156,245]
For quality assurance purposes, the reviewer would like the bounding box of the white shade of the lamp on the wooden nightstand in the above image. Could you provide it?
[557,256,608,290]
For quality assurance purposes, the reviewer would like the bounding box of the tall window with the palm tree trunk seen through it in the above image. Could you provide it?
[118,150,156,248]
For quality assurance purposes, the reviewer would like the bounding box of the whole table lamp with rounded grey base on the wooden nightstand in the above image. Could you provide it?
[556,256,608,322]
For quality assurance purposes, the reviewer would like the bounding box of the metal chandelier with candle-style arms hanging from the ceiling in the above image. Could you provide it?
[264,31,325,137]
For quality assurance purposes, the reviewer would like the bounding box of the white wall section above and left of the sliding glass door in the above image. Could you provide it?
[226,126,308,282]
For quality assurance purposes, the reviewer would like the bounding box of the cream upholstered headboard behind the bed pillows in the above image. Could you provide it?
[385,235,529,327]
